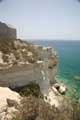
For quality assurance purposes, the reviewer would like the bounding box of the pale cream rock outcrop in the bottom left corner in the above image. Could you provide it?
[0,87,21,120]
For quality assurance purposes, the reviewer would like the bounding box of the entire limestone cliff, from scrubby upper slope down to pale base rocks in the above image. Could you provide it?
[0,21,63,106]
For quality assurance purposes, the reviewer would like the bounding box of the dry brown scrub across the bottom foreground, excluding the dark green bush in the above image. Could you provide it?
[13,96,80,120]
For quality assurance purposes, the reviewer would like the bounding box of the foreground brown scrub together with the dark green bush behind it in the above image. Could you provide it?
[13,83,80,120]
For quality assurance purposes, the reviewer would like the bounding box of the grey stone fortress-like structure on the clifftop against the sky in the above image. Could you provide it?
[0,22,17,39]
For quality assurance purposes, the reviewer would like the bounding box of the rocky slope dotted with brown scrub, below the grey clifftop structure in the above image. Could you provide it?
[0,37,40,65]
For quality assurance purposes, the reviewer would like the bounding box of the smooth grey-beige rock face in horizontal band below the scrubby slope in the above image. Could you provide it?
[0,63,49,93]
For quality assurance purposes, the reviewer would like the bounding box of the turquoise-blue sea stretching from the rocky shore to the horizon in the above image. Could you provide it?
[31,40,80,99]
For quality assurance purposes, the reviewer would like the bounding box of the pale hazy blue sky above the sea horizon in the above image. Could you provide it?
[0,0,80,40]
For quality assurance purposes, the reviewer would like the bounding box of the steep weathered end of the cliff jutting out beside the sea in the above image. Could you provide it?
[35,46,57,83]
